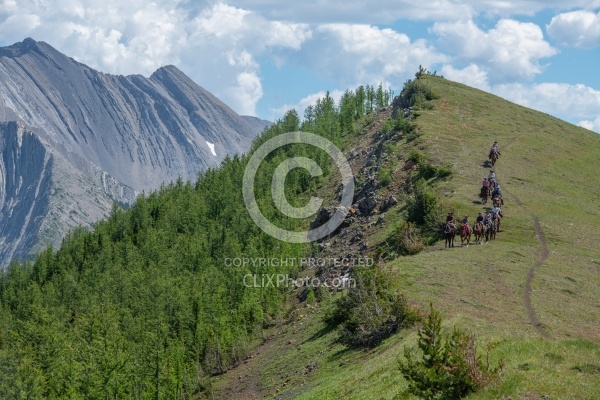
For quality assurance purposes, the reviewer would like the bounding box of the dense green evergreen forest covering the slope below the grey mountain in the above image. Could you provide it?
[0,85,392,399]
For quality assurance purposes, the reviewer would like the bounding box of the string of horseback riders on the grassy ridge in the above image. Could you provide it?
[443,141,504,246]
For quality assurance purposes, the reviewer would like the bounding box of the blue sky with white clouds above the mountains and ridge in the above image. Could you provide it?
[0,0,600,132]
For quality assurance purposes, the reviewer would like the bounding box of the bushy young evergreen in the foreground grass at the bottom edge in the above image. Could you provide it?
[399,306,503,400]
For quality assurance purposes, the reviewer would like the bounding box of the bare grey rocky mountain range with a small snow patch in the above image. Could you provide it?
[0,38,269,266]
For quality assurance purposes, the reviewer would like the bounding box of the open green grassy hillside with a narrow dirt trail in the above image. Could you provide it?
[215,76,600,399]
